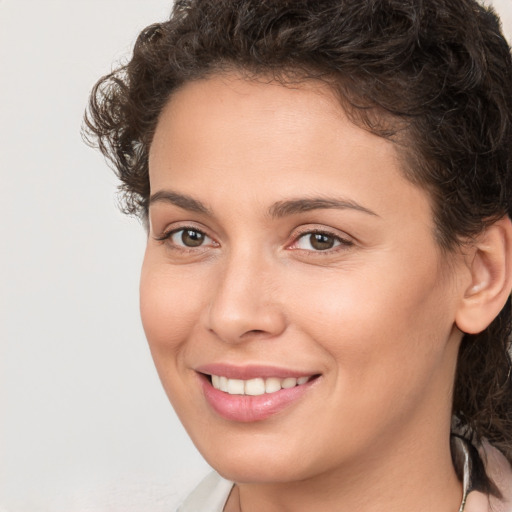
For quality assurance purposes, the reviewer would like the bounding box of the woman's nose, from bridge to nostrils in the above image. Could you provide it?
[204,250,286,343]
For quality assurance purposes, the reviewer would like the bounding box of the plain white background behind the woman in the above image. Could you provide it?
[0,0,512,512]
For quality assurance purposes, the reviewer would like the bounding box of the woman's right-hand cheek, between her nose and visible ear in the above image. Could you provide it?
[288,265,453,389]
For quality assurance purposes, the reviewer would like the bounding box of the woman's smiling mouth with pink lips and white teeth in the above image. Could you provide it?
[196,367,321,423]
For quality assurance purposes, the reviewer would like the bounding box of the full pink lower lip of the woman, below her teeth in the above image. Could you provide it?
[200,375,317,423]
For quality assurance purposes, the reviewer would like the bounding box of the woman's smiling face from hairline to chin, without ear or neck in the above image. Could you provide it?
[141,76,461,482]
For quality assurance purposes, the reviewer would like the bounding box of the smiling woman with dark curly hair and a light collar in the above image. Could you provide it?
[86,0,512,512]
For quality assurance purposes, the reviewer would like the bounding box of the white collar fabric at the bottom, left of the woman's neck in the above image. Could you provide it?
[176,471,233,512]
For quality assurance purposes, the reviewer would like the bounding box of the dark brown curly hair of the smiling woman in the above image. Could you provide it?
[85,0,512,490]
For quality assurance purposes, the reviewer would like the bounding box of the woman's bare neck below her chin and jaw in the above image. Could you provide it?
[225,428,462,512]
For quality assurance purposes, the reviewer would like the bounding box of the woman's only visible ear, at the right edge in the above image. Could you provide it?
[455,217,512,334]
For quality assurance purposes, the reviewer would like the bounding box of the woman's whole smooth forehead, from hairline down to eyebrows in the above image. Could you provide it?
[149,75,432,224]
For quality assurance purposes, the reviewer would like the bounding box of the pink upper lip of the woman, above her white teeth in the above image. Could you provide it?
[194,363,318,380]
